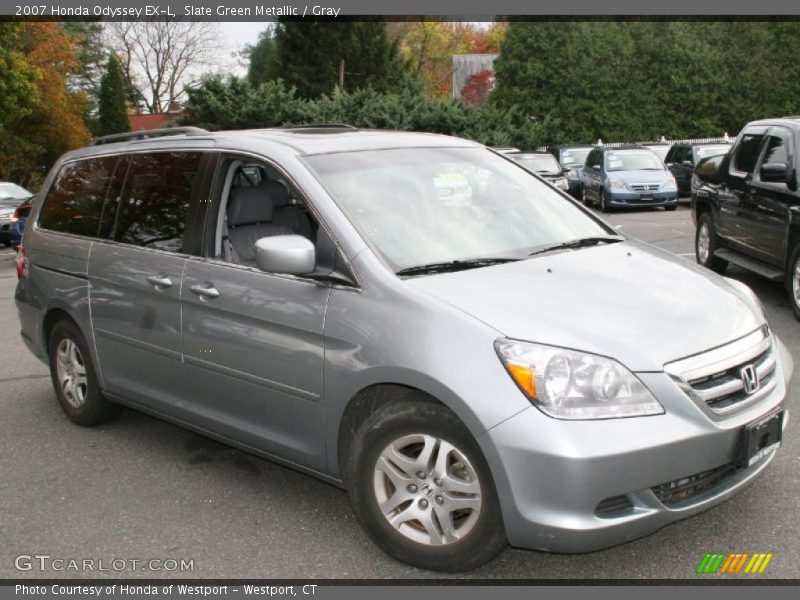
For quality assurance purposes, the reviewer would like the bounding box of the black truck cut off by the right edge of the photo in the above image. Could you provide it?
[692,117,800,318]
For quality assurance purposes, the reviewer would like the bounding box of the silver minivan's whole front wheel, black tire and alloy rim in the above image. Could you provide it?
[347,397,506,571]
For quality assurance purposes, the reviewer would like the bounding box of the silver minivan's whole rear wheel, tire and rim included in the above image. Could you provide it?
[48,320,121,425]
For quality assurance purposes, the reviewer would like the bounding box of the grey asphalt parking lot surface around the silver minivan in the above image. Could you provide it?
[0,207,800,580]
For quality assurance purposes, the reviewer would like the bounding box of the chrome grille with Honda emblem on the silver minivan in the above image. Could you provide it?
[664,327,778,415]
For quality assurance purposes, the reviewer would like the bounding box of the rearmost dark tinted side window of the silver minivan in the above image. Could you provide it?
[39,156,124,237]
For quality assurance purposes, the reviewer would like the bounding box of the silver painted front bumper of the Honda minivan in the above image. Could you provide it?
[479,347,791,553]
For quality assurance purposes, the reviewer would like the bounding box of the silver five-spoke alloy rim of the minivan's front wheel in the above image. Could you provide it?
[373,434,482,546]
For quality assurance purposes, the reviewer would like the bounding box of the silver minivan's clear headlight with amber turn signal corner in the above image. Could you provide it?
[495,338,664,419]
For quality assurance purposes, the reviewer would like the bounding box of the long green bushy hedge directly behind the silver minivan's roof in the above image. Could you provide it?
[181,75,555,149]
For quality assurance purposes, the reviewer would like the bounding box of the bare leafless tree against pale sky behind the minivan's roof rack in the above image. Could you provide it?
[106,21,220,113]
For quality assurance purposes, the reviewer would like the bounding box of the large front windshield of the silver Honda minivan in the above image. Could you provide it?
[305,148,614,271]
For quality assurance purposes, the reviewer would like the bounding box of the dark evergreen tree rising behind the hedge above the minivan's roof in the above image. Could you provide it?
[274,21,404,98]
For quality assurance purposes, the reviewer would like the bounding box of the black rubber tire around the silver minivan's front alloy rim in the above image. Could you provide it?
[346,395,507,572]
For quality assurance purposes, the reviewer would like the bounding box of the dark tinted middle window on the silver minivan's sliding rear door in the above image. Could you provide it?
[114,152,202,252]
